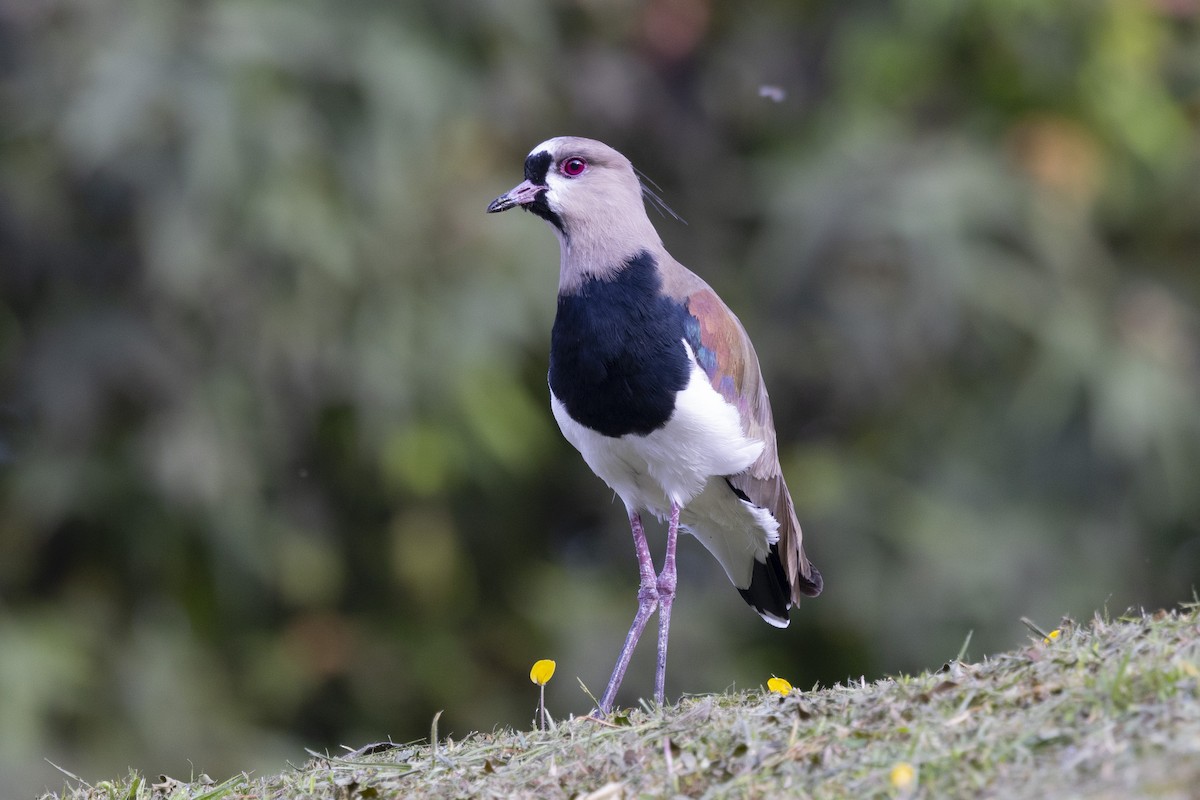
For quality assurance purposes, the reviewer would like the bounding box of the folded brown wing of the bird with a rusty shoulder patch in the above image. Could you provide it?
[686,285,822,602]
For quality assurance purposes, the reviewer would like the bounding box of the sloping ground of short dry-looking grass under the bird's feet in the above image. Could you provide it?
[37,603,1200,800]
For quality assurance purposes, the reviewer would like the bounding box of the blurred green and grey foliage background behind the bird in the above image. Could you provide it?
[0,0,1200,796]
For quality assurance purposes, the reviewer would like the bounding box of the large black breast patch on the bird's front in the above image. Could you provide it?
[550,251,691,437]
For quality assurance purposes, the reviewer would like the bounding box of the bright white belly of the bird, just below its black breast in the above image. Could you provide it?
[551,352,763,518]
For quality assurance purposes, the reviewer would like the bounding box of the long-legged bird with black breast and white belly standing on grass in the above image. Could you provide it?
[487,136,823,714]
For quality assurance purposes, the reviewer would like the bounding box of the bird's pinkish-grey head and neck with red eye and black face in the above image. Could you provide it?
[487,137,661,280]
